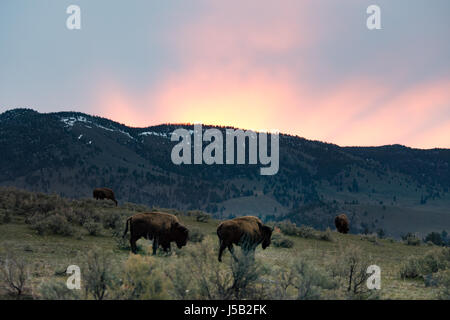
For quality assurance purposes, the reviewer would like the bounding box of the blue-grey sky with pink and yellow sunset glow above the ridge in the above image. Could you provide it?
[0,0,450,148]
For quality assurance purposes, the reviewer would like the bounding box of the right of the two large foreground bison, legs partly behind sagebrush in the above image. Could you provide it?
[217,216,272,262]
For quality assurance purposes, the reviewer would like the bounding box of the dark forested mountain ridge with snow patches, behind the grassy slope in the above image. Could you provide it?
[0,109,450,237]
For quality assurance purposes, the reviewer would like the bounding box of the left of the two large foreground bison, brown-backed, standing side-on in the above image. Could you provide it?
[123,212,189,254]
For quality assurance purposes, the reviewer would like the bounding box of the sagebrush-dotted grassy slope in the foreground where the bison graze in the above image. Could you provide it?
[0,189,450,299]
